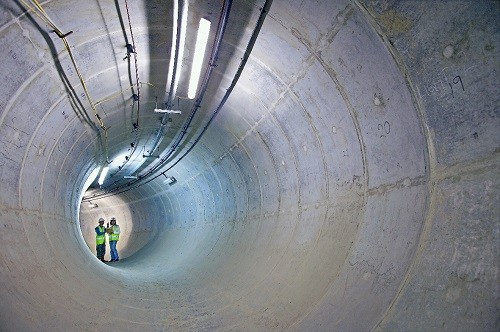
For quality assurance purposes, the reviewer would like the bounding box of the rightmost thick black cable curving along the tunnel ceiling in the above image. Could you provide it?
[84,0,273,200]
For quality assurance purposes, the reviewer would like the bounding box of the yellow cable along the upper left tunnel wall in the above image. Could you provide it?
[21,0,109,163]
